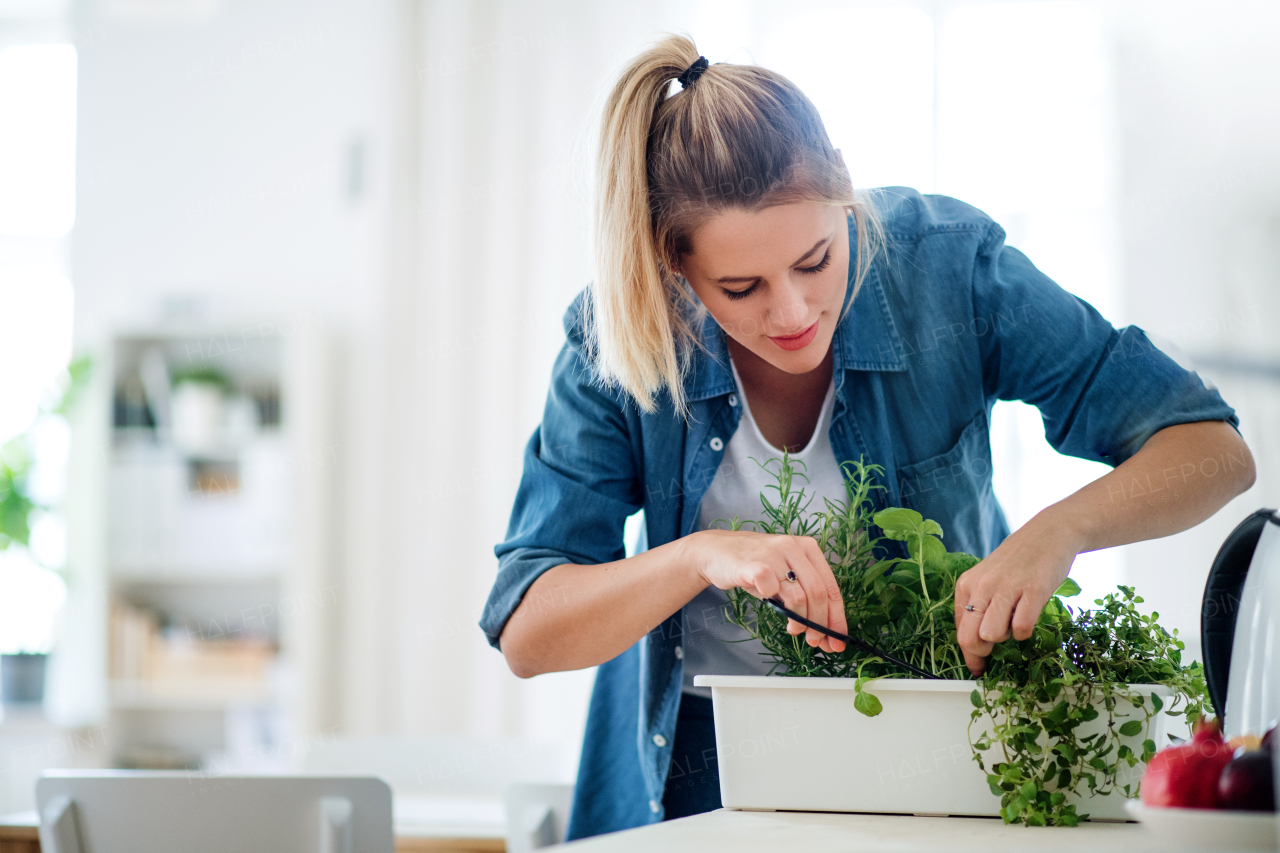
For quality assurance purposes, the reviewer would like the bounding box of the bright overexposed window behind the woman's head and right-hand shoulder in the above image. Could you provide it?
[759,0,1123,599]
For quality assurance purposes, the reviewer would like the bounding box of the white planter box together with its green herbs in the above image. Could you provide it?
[695,457,1208,826]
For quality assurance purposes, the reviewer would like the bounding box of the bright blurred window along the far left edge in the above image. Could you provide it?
[0,33,76,654]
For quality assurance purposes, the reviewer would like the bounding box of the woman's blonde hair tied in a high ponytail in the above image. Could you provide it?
[586,36,883,415]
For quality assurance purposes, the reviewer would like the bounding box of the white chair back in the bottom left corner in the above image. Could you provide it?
[36,770,396,853]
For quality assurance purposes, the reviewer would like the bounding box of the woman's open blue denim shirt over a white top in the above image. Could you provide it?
[480,187,1238,838]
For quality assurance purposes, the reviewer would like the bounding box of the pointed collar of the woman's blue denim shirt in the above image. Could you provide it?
[685,257,906,402]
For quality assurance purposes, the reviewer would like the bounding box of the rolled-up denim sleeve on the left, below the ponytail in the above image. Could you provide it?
[480,343,643,648]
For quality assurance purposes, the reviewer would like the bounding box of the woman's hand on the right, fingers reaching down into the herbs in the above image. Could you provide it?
[956,516,1080,675]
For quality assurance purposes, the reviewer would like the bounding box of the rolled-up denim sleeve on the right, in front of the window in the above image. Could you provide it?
[973,223,1239,466]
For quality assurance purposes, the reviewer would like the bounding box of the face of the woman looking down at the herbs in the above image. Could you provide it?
[680,202,849,374]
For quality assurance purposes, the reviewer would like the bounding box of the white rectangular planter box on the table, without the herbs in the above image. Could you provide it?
[694,675,1171,820]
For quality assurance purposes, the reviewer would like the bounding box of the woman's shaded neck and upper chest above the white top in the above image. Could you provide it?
[728,338,835,453]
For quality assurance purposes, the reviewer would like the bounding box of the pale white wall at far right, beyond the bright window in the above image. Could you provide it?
[1114,0,1280,640]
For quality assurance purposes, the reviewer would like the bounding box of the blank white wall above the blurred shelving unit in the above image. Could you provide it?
[73,0,396,339]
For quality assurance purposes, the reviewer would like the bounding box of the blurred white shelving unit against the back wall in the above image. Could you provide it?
[81,318,338,768]
